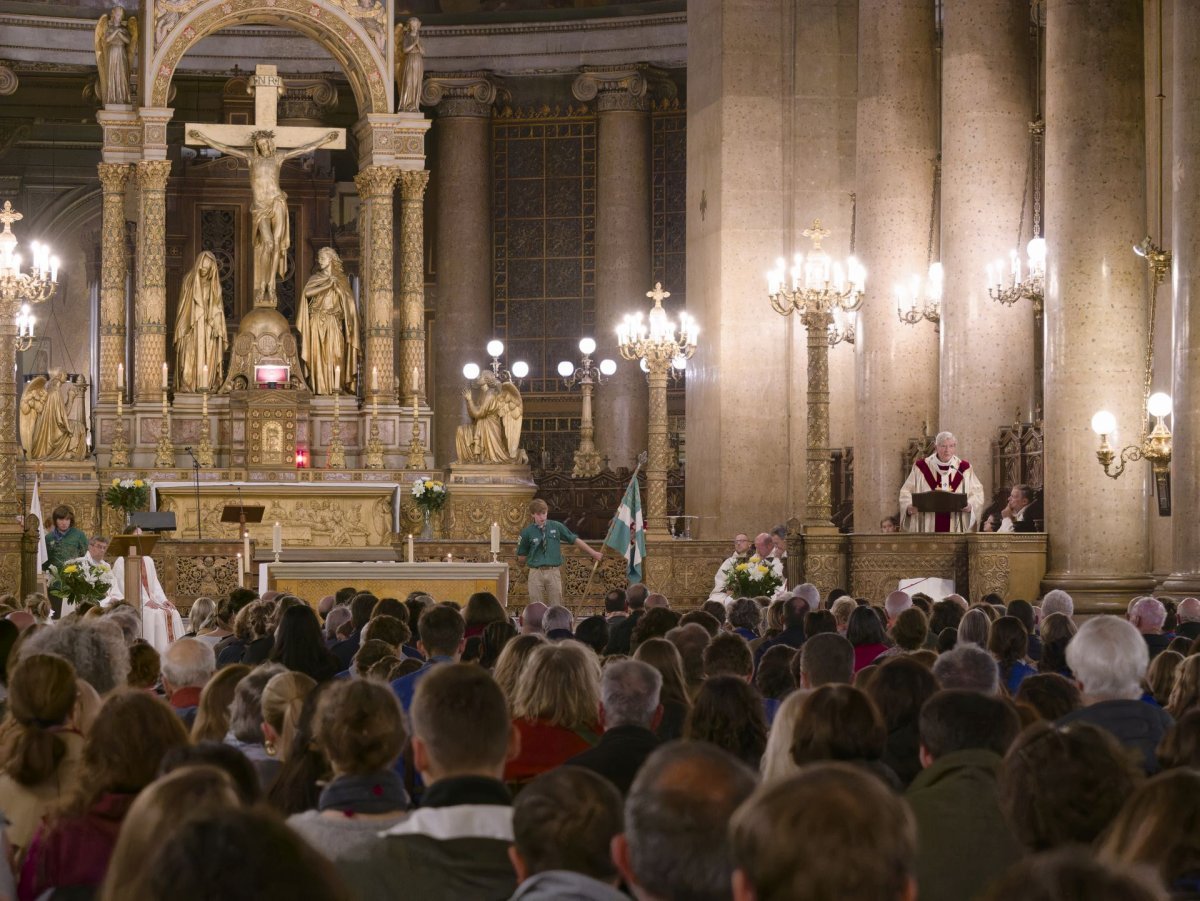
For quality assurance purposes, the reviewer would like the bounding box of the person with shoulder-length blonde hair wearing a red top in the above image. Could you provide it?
[504,641,600,782]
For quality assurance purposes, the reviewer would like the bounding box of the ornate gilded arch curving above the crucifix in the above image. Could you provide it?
[144,0,392,116]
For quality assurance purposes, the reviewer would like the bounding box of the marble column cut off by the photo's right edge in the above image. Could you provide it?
[1153,4,1200,595]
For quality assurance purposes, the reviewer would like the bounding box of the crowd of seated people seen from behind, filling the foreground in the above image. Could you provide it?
[0,584,1200,901]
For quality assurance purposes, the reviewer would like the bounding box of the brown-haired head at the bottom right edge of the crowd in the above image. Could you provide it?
[1097,769,1200,888]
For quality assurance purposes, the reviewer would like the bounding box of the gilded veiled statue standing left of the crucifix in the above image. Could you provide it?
[175,251,229,391]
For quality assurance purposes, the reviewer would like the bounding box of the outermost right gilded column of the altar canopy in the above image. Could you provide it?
[398,169,430,403]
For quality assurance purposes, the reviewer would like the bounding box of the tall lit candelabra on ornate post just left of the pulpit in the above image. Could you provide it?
[767,220,866,525]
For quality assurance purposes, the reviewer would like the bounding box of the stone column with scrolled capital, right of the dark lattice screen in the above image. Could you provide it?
[571,66,657,469]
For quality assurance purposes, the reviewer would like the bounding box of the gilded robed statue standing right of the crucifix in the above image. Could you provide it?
[296,247,361,395]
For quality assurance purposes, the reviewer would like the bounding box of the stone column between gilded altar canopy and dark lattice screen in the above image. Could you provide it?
[421,72,496,467]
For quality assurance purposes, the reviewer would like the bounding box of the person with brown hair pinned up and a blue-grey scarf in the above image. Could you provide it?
[288,679,409,860]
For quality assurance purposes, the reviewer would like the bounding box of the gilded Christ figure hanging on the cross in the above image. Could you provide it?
[187,128,338,307]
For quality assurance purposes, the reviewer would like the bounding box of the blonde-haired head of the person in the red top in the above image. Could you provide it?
[512,642,600,728]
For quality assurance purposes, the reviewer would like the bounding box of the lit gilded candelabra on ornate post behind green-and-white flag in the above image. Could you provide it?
[617,282,700,537]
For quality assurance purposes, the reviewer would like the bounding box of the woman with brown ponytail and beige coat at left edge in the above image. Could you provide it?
[0,654,84,859]
